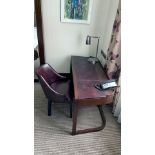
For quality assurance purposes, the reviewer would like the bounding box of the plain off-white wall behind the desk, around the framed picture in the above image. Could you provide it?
[41,0,119,73]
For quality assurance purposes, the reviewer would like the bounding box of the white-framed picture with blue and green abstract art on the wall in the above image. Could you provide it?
[61,0,93,24]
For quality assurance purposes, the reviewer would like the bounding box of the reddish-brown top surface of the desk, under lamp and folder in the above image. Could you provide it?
[71,56,113,100]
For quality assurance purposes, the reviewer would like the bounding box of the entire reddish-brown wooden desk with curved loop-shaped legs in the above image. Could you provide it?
[71,56,113,135]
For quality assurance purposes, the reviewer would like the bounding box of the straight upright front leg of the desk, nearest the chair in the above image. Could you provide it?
[72,103,79,135]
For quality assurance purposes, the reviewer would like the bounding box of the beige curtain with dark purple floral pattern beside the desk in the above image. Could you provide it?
[105,1,121,122]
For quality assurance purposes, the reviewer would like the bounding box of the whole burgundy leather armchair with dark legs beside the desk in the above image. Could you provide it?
[36,64,73,117]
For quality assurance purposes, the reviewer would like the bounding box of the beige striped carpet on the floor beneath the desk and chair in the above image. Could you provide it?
[34,83,121,155]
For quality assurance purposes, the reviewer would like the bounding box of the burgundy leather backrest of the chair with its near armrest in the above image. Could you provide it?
[36,64,61,99]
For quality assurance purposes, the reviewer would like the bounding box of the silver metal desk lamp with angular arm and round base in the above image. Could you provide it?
[86,35,100,64]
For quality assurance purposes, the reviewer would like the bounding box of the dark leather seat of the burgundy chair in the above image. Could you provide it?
[50,80,73,102]
